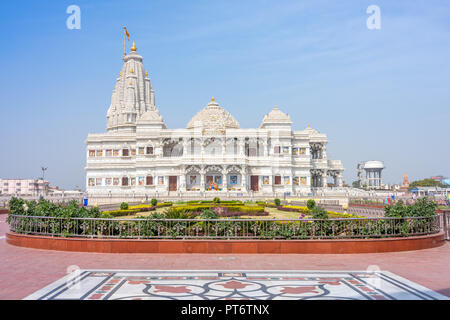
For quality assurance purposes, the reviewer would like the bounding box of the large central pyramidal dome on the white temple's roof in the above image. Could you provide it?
[186,97,239,131]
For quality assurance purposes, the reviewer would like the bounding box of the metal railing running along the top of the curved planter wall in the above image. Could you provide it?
[9,215,441,239]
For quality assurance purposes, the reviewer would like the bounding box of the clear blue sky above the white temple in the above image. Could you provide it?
[0,0,450,189]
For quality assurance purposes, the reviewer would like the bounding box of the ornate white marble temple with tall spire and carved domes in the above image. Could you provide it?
[86,43,344,198]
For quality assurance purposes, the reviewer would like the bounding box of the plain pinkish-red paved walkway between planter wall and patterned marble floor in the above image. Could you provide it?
[0,215,450,299]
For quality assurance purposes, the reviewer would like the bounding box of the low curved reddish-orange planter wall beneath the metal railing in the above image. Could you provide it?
[6,232,445,254]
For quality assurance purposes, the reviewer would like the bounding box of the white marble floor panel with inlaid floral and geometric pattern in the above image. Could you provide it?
[25,270,449,300]
